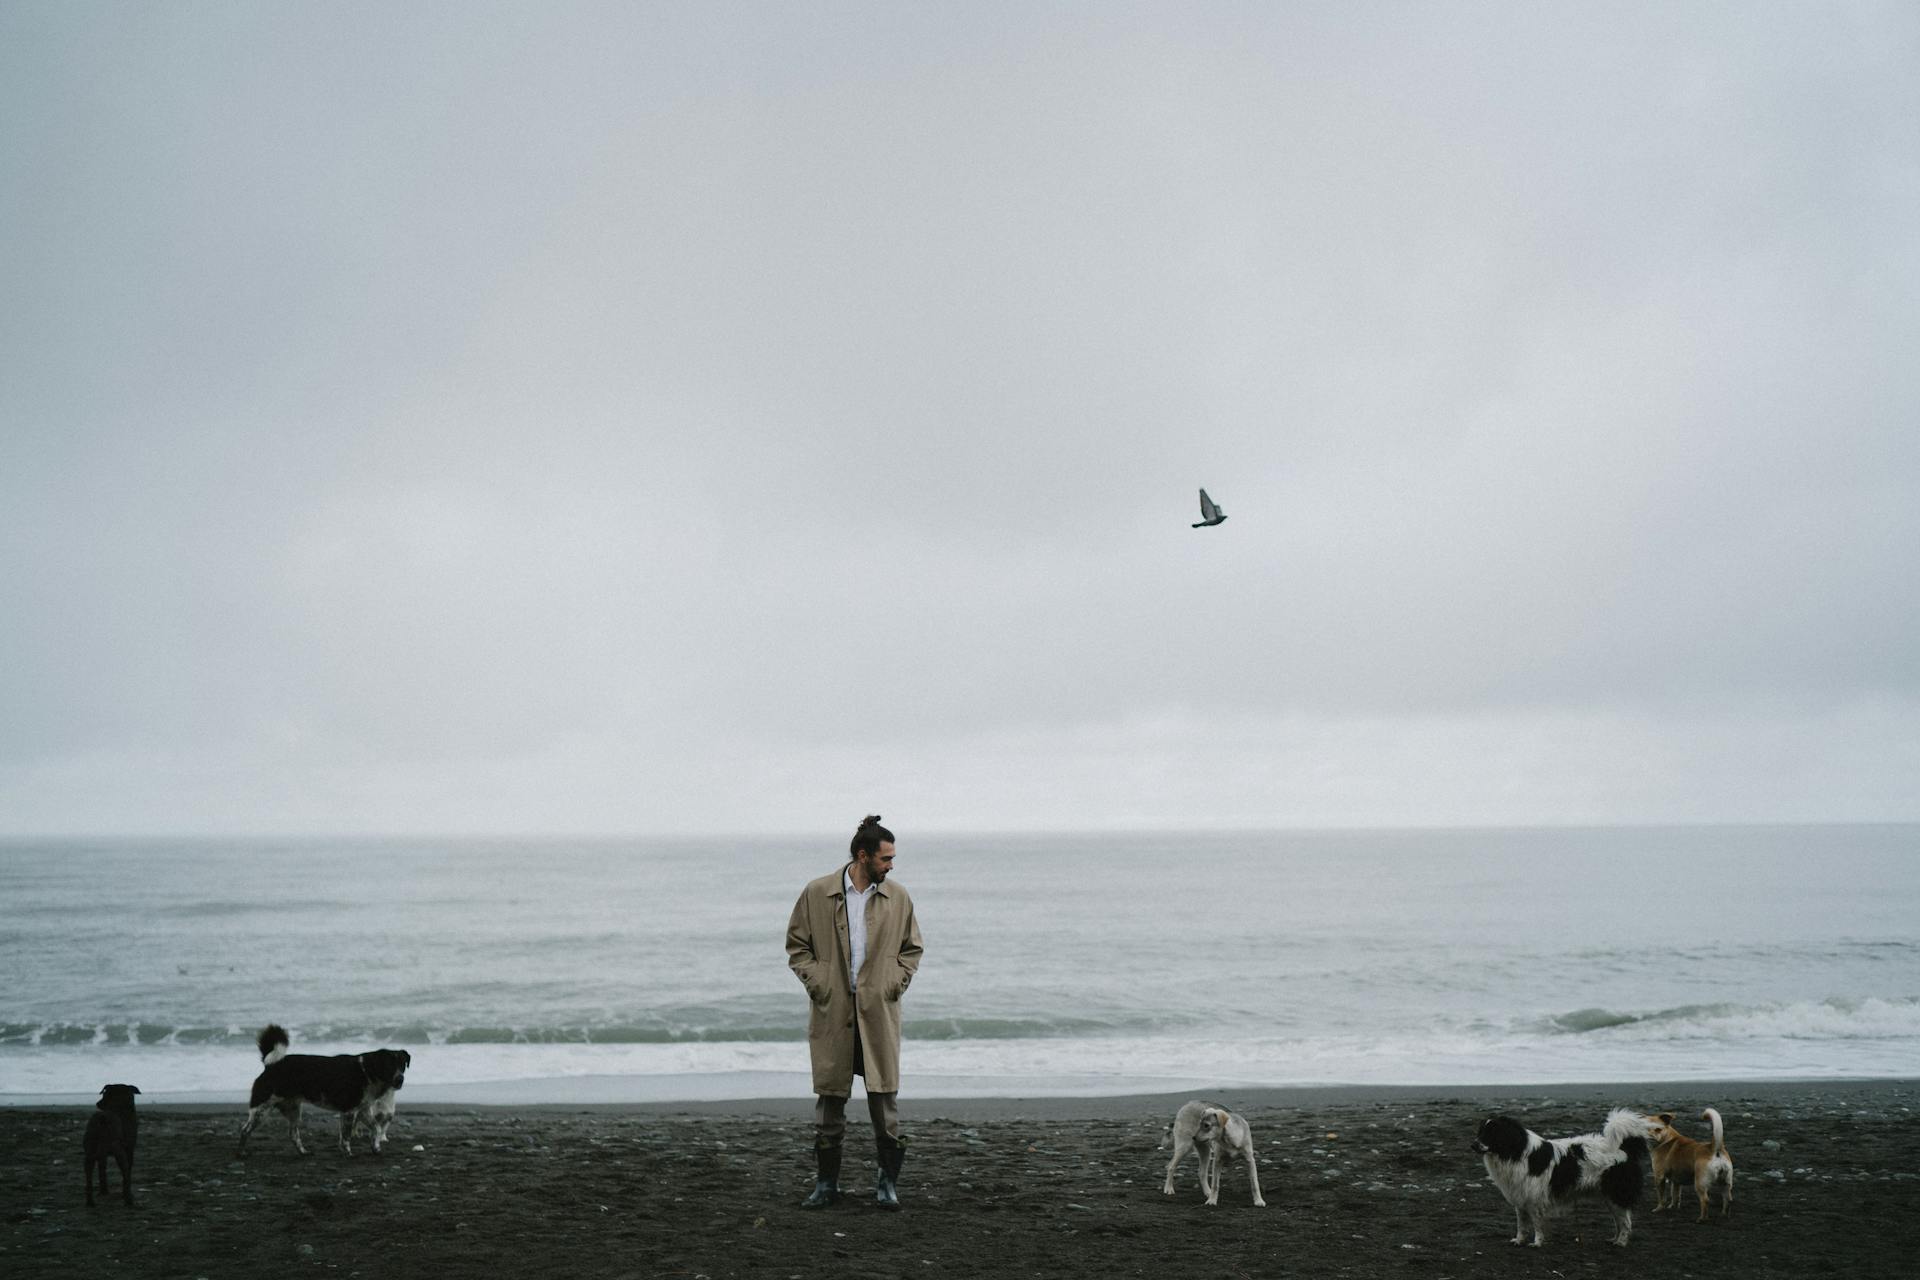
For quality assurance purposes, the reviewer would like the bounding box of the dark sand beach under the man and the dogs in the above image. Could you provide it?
[0,1080,1920,1280]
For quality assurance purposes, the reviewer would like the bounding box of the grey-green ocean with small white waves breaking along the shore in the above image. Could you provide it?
[0,825,1920,1103]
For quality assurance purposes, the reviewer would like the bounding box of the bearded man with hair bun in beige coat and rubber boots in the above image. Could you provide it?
[787,814,922,1209]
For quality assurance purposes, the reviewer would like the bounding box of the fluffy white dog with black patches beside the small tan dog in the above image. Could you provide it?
[1473,1107,1647,1245]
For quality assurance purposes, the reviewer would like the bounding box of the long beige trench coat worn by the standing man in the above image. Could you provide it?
[787,864,922,1098]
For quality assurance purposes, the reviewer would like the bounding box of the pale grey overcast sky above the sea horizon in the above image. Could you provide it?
[0,0,1920,839]
